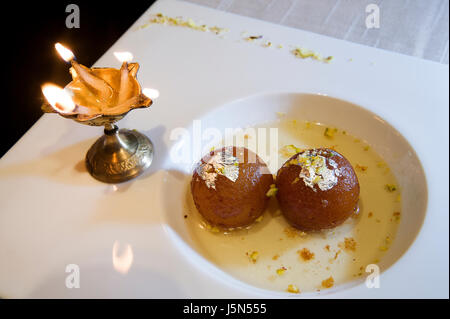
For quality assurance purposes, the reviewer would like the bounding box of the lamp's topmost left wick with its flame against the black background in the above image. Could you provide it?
[55,43,114,105]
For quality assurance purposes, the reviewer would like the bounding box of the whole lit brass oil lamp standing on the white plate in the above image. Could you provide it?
[42,43,159,183]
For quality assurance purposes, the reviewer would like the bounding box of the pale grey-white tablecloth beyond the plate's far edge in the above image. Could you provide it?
[184,0,449,64]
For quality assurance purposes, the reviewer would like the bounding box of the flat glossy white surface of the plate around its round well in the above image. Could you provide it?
[0,0,449,298]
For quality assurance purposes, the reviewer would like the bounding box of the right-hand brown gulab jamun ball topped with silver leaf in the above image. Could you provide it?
[276,148,359,231]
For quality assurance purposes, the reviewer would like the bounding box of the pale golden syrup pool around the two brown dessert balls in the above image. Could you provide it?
[185,118,401,293]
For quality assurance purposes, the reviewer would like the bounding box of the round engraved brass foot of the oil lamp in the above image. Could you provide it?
[85,125,153,184]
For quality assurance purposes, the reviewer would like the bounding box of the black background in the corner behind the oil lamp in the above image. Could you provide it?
[0,0,154,157]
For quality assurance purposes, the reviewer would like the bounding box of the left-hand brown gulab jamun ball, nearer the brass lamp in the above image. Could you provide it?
[191,147,273,228]
